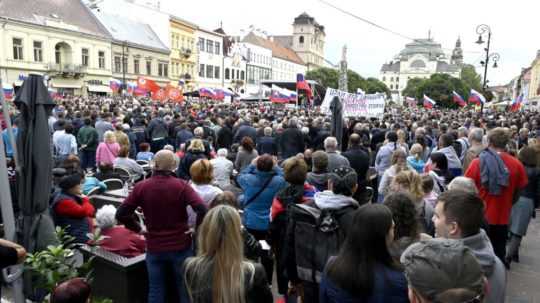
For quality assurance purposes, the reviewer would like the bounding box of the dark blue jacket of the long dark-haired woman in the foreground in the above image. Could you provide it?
[319,265,409,303]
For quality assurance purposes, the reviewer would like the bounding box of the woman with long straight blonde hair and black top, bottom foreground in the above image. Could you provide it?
[184,205,273,303]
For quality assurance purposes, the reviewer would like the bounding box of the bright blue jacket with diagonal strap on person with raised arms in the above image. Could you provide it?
[237,164,287,230]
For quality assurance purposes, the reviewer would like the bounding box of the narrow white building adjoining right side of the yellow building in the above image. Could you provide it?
[195,28,224,88]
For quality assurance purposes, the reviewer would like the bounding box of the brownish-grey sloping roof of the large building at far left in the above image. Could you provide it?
[0,0,110,38]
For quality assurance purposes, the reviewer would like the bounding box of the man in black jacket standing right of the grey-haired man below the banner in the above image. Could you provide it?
[341,134,369,204]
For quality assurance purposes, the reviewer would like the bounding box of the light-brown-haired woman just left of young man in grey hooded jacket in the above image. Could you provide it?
[390,170,435,235]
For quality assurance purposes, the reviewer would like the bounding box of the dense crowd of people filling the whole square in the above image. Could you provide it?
[0,97,540,303]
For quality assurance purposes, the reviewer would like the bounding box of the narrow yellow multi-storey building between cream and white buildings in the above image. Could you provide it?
[169,16,198,90]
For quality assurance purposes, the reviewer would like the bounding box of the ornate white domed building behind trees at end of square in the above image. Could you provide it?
[379,38,463,102]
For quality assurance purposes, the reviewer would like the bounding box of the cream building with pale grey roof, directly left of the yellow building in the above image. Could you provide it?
[94,11,171,86]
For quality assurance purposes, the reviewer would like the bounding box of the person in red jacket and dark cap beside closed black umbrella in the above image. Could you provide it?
[51,173,95,243]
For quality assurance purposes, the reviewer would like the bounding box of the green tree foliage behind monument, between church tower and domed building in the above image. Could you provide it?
[306,67,390,96]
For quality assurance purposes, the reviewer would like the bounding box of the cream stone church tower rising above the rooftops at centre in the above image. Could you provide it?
[292,13,326,70]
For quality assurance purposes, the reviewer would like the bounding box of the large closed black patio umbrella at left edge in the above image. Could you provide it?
[14,75,57,252]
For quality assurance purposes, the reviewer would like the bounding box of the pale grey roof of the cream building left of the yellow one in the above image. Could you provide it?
[95,12,169,52]
